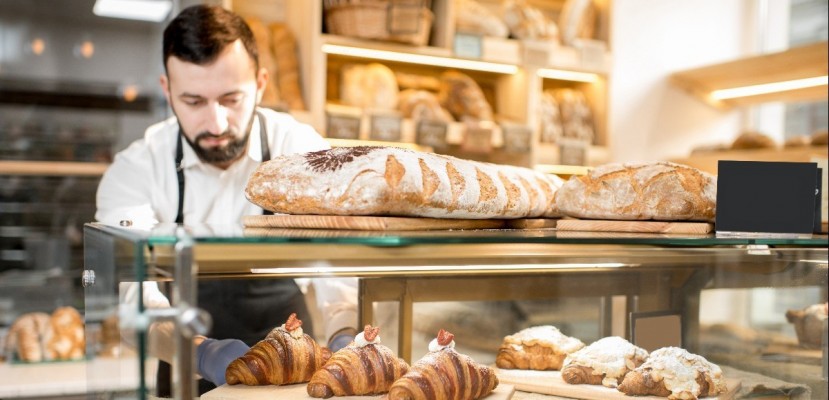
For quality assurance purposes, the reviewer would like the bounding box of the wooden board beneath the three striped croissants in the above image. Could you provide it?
[201,383,515,400]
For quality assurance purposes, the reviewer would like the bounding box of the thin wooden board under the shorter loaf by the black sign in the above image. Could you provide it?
[556,219,714,235]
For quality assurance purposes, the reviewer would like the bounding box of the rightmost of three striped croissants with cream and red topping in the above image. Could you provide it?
[389,329,498,400]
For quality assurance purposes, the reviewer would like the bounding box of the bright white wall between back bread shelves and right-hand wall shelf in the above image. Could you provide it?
[609,0,756,161]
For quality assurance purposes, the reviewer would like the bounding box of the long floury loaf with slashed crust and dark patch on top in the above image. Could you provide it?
[245,147,561,219]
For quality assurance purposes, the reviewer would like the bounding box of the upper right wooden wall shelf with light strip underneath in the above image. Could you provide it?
[671,41,829,109]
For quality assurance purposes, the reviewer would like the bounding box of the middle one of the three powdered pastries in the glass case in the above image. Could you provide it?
[561,336,648,388]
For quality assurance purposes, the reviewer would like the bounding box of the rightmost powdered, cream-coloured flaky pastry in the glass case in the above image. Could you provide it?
[618,347,727,400]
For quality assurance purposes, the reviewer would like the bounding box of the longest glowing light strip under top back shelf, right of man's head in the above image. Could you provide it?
[322,44,518,75]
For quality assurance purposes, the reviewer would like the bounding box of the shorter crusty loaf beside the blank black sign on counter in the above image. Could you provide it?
[556,162,717,221]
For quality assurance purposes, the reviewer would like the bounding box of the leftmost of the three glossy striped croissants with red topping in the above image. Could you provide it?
[225,314,331,386]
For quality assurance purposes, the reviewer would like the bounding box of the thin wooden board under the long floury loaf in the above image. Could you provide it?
[242,214,505,231]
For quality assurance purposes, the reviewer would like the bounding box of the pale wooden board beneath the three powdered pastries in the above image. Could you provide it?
[493,367,740,400]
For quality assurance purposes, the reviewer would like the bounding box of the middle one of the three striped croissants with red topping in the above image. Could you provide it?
[307,325,409,398]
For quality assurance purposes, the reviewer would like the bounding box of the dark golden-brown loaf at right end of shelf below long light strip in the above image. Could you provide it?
[438,71,492,121]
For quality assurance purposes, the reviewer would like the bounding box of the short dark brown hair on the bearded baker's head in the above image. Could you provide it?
[162,5,259,71]
